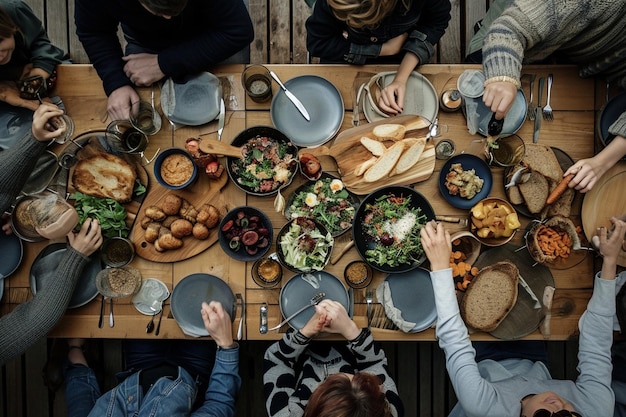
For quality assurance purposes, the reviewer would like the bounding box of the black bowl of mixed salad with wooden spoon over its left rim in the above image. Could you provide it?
[226,126,298,197]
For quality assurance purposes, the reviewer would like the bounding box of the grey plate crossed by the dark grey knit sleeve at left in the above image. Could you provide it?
[30,243,103,308]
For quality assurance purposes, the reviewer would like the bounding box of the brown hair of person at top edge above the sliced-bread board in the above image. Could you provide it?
[328,0,411,29]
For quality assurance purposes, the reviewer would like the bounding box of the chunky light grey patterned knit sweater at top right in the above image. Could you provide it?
[483,0,626,137]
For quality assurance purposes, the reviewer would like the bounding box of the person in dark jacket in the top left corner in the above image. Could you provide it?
[0,0,65,111]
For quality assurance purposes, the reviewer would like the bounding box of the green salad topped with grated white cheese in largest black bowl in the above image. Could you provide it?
[363,194,427,267]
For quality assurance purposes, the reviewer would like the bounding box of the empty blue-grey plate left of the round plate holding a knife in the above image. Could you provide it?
[161,72,222,126]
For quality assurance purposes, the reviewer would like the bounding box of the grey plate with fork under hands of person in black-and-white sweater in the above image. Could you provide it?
[280,271,352,330]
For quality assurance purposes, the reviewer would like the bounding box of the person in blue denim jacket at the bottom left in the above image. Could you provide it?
[65,301,241,417]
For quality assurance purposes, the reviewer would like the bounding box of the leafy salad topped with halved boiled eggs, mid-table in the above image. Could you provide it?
[285,176,358,236]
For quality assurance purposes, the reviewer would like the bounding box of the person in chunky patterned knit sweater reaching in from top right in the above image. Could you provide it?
[472,0,626,192]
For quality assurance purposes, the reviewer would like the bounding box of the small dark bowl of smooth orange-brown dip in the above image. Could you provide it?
[154,148,198,190]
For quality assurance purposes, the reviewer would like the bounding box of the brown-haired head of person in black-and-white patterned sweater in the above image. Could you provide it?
[304,373,391,417]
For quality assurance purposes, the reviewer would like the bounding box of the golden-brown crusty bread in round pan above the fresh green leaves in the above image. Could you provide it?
[72,152,137,203]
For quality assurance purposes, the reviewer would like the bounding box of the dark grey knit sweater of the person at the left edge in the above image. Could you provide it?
[0,134,89,365]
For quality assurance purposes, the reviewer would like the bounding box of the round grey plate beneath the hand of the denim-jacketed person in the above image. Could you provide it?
[171,274,237,336]
